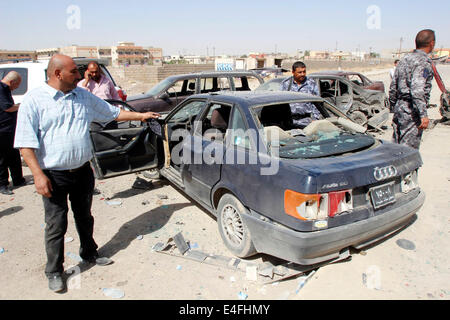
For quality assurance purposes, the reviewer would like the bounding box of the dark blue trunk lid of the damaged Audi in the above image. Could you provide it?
[281,140,422,194]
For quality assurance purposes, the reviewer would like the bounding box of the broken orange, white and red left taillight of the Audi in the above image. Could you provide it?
[284,190,353,220]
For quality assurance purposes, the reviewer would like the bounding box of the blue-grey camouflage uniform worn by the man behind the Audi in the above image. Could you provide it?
[281,77,322,129]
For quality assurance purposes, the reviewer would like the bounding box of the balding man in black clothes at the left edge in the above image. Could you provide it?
[0,71,26,195]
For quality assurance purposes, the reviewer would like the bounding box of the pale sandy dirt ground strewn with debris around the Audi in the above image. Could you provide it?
[0,66,450,300]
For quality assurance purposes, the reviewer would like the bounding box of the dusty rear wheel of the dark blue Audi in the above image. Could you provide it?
[217,194,257,258]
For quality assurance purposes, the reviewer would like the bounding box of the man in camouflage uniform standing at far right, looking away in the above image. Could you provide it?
[389,29,436,149]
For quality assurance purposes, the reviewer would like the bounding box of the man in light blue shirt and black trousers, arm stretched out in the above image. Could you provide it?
[14,55,159,292]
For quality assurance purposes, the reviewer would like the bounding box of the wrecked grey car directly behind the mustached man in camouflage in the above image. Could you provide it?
[256,73,389,129]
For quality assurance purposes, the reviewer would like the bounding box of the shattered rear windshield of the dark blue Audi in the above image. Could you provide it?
[254,101,375,159]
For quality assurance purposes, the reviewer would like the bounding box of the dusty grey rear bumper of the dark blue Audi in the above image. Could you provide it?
[242,191,425,265]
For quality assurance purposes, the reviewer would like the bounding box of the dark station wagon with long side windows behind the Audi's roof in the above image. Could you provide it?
[127,71,264,113]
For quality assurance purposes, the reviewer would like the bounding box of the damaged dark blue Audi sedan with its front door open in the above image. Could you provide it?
[91,92,425,265]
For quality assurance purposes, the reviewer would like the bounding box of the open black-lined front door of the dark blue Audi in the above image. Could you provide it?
[90,100,158,179]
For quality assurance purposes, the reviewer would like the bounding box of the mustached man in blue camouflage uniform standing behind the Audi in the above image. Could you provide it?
[281,61,322,129]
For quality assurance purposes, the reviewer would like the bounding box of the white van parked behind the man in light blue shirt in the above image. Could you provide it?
[0,58,127,103]
